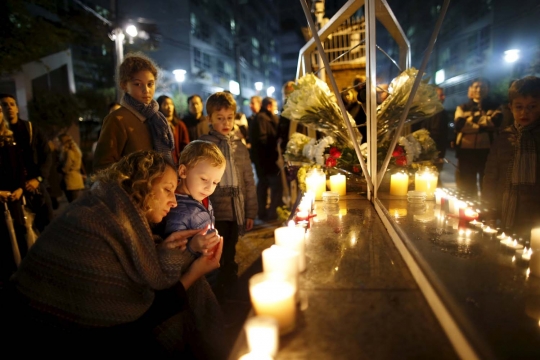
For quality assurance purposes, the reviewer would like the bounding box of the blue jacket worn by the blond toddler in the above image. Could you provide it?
[161,194,215,237]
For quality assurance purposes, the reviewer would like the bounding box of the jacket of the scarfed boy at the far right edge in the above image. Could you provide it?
[482,125,540,230]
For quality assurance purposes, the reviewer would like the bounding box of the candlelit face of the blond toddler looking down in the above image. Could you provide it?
[178,161,225,201]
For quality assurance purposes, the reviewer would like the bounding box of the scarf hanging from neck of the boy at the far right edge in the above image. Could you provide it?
[502,121,540,227]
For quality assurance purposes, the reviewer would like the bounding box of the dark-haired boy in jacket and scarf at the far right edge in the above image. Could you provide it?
[483,76,540,232]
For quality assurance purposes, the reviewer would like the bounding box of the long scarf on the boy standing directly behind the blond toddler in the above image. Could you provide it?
[209,125,245,236]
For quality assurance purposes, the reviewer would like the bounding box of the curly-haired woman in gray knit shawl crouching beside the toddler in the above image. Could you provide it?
[0,151,226,358]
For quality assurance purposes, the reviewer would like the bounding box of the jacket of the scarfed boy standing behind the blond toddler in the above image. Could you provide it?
[201,135,257,222]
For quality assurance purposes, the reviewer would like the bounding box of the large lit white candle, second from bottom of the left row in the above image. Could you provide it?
[249,273,296,334]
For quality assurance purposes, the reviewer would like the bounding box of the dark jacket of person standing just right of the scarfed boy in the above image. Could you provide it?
[250,109,279,176]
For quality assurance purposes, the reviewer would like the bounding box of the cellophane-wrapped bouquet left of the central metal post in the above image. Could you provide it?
[282,74,362,148]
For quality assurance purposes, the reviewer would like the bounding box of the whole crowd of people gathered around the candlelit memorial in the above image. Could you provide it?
[0,47,540,359]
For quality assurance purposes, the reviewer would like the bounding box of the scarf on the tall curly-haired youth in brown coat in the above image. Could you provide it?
[120,93,174,160]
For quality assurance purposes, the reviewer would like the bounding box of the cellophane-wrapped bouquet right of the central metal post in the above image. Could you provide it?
[377,68,443,142]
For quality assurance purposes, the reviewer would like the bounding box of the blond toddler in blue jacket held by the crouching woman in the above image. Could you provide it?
[160,140,225,256]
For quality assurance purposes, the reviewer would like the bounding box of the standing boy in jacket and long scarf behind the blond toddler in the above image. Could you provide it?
[200,92,257,291]
